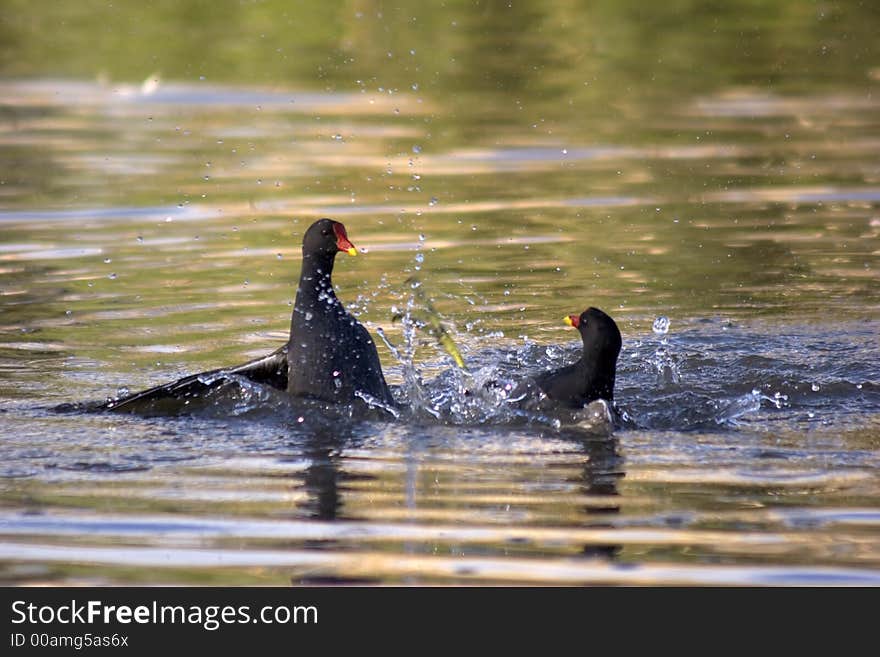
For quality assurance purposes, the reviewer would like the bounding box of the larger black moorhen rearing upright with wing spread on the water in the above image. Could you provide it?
[95,219,394,413]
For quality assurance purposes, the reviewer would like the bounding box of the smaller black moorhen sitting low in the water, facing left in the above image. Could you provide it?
[535,308,621,408]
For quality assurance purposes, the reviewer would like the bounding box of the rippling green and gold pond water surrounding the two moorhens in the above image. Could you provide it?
[0,3,880,585]
